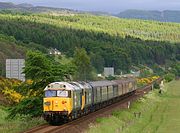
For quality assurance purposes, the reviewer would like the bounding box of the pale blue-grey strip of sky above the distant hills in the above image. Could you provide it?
[0,0,180,13]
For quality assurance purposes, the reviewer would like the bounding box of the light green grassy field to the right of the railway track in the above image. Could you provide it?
[88,81,180,133]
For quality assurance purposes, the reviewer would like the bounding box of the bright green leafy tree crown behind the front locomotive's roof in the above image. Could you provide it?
[24,51,75,83]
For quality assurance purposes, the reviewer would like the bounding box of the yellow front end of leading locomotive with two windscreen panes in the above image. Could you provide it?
[43,82,73,123]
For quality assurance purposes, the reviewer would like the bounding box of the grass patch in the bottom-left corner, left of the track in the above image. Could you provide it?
[0,106,45,133]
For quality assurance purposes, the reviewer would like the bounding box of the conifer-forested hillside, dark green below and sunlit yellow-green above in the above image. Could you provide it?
[0,11,180,74]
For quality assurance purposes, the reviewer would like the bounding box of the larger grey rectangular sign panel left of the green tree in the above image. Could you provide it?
[6,59,25,81]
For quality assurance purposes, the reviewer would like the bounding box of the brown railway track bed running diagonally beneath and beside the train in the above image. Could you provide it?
[24,81,158,133]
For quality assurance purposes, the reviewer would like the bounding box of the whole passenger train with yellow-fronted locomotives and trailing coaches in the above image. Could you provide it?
[43,79,137,124]
